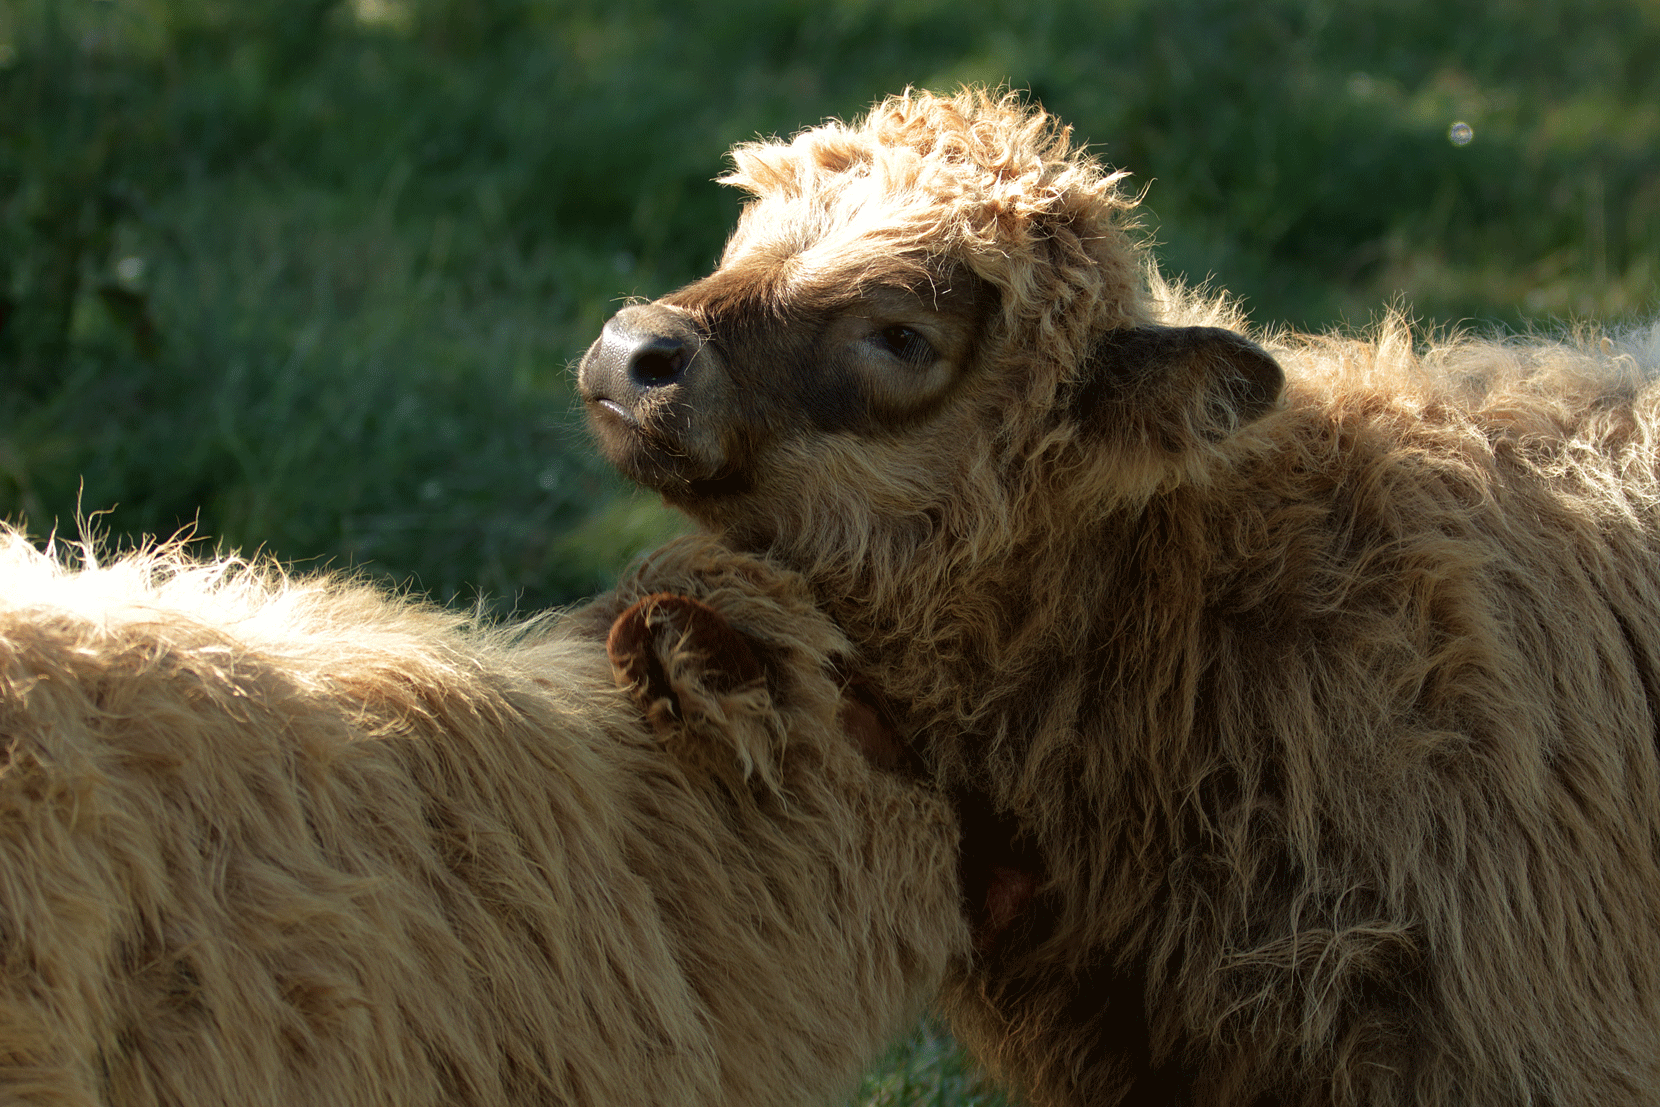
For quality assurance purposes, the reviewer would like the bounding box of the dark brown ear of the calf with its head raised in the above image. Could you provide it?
[1066,325,1285,453]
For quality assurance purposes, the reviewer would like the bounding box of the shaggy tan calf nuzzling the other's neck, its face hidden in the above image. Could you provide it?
[0,534,966,1107]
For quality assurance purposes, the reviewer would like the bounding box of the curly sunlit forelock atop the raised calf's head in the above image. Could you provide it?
[720,88,1149,367]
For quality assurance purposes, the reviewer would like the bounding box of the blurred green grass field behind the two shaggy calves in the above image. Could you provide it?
[0,0,1660,1105]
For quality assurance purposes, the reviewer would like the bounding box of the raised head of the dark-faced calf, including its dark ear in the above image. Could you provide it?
[579,93,1282,564]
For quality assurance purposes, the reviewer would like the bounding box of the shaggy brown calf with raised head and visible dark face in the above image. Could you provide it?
[581,93,1660,1105]
